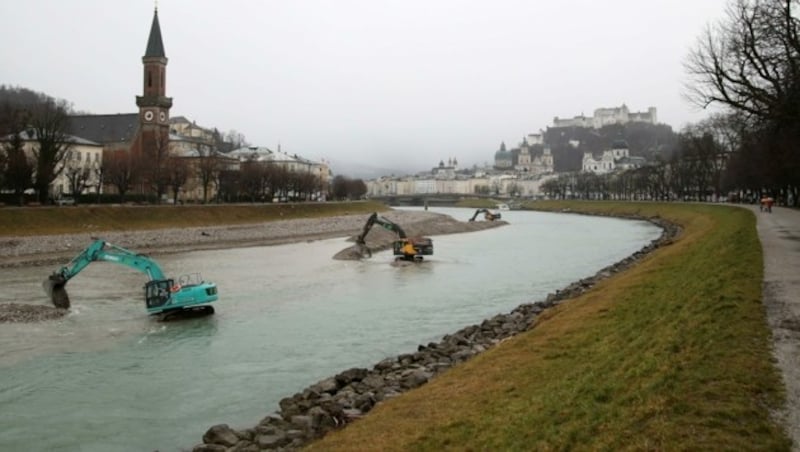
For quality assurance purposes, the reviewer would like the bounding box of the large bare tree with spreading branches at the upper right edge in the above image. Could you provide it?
[686,0,800,205]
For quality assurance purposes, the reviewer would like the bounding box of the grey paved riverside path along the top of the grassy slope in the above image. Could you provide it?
[751,207,800,451]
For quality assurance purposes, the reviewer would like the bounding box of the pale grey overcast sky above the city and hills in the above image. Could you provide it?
[0,0,727,177]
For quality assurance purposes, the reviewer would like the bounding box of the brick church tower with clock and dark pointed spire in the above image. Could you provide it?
[136,8,172,155]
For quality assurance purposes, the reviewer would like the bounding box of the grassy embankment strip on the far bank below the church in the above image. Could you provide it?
[0,202,387,236]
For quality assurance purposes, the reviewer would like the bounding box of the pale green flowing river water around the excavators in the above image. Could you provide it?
[0,208,661,452]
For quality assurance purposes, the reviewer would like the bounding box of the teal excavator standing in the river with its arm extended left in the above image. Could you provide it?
[43,239,218,320]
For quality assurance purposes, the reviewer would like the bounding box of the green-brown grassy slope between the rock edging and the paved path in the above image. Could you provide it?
[310,202,790,451]
